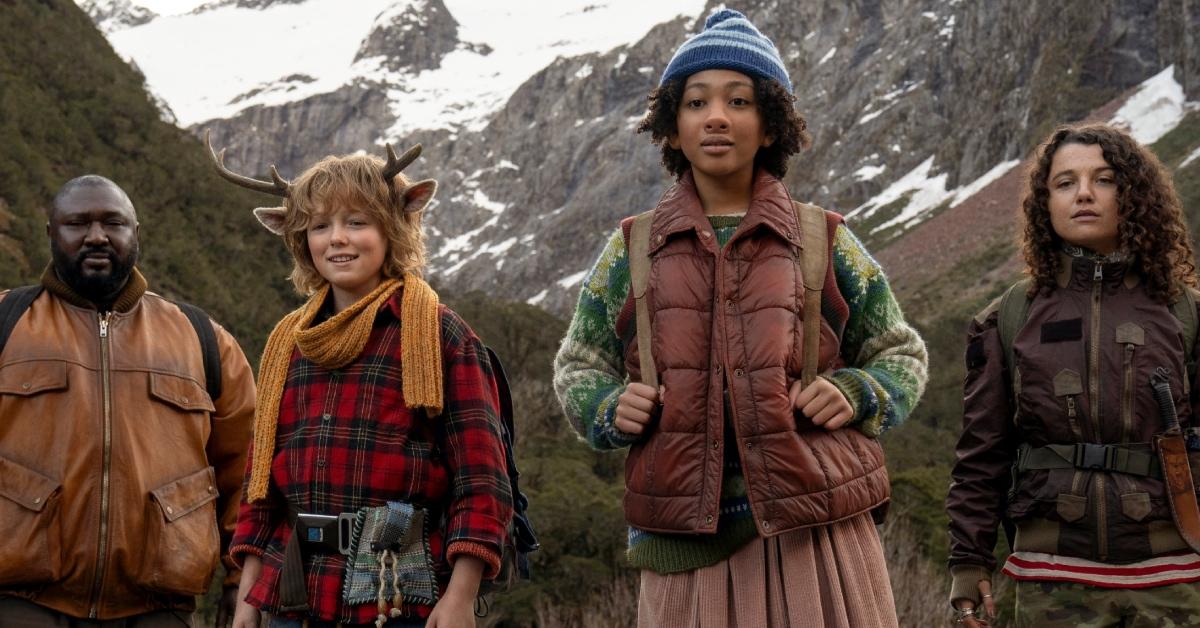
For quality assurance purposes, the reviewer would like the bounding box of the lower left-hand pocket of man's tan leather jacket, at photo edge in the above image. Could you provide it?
[0,456,62,586]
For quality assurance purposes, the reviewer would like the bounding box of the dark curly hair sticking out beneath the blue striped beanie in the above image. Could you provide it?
[637,77,812,179]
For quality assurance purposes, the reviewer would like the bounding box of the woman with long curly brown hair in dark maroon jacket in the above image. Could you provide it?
[946,125,1200,627]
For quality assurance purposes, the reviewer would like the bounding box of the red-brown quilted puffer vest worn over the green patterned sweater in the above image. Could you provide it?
[624,173,889,537]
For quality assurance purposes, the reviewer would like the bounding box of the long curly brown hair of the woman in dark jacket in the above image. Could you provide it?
[1021,124,1198,304]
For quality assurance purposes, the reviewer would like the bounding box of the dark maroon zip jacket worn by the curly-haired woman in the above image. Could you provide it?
[946,256,1200,599]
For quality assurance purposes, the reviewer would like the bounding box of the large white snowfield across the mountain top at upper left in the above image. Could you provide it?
[96,0,704,130]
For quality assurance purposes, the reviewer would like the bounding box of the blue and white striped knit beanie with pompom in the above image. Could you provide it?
[659,8,792,91]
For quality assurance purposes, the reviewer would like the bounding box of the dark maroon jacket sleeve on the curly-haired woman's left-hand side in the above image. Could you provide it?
[946,309,1019,581]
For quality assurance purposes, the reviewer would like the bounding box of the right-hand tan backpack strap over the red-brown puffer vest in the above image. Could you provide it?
[792,201,829,387]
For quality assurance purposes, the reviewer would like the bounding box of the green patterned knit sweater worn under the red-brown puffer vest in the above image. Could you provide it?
[554,216,928,573]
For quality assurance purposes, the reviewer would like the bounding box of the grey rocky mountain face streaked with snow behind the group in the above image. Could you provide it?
[162,0,1200,313]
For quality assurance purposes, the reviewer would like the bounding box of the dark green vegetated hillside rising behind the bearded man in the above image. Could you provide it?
[0,0,298,363]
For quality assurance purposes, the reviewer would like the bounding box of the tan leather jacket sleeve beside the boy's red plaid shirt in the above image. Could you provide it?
[205,323,256,586]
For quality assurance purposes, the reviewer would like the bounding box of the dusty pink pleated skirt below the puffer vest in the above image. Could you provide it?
[637,513,898,628]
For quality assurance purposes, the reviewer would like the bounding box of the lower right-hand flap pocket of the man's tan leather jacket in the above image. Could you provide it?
[137,467,221,596]
